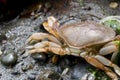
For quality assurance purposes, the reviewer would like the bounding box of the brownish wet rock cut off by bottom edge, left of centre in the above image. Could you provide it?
[37,70,60,80]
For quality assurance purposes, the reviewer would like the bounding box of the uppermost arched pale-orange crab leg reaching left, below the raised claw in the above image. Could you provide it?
[27,33,61,44]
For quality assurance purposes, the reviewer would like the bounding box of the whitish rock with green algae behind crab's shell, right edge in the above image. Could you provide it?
[100,16,120,35]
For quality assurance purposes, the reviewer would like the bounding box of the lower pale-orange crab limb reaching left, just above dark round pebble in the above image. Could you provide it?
[27,41,66,55]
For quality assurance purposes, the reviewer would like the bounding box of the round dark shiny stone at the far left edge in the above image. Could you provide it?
[1,52,18,66]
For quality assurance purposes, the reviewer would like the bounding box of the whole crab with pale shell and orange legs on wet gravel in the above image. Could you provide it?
[27,16,120,80]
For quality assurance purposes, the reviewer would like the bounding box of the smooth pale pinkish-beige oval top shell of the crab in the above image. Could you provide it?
[56,21,115,49]
